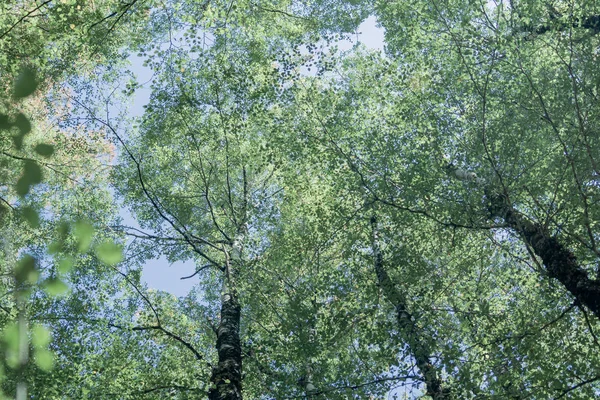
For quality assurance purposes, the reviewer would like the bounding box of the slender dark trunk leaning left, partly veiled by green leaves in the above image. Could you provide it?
[371,216,452,400]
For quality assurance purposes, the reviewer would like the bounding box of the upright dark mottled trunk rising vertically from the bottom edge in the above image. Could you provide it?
[208,291,242,400]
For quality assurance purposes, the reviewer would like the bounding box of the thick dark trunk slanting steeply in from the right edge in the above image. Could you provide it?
[489,195,600,318]
